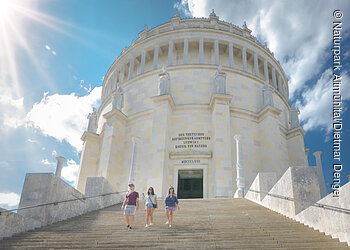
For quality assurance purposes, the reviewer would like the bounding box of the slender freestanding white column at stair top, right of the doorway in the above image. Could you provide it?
[234,135,246,198]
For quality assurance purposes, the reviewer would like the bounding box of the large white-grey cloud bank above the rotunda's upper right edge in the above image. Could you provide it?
[185,0,350,97]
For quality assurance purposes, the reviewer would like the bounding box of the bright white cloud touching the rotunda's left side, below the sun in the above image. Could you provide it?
[27,87,102,151]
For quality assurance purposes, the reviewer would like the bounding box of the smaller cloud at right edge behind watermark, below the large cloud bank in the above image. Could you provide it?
[297,69,350,131]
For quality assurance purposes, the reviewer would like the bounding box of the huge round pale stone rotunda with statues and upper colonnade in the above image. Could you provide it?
[78,11,308,198]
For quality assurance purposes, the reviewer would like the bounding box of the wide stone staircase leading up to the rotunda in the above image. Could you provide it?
[0,199,349,249]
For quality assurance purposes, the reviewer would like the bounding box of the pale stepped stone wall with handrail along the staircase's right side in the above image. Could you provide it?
[245,167,350,245]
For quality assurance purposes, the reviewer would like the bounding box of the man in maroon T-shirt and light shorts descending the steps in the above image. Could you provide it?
[122,183,139,230]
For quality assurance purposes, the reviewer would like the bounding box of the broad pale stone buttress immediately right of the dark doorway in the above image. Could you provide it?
[208,94,233,198]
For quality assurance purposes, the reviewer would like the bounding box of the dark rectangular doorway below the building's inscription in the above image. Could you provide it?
[177,169,203,199]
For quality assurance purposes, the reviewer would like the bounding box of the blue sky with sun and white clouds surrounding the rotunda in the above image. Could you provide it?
[0,0,350,208]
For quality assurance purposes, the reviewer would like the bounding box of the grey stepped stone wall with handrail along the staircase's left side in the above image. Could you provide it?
[0,173,124,239]
